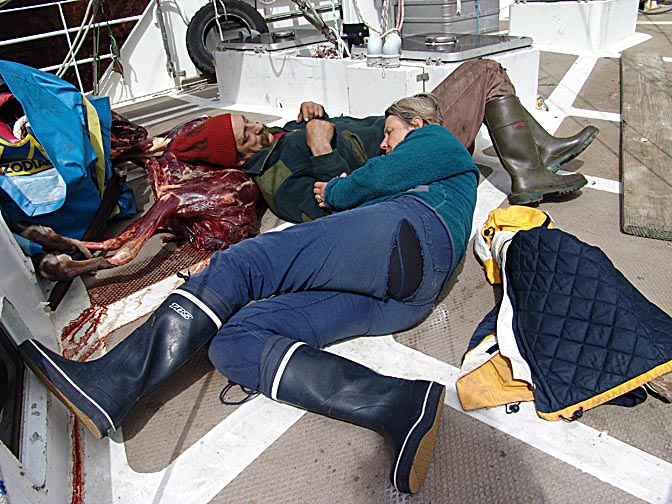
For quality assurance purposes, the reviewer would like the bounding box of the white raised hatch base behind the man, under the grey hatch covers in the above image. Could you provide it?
[215,47,539,119]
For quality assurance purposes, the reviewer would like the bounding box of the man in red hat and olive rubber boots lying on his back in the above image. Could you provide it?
[173,59,599,222]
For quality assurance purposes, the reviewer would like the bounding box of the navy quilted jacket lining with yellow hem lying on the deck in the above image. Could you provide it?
[470,227,672,420]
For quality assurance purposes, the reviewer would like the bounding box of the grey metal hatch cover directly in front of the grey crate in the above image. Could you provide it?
[401,33,532,63]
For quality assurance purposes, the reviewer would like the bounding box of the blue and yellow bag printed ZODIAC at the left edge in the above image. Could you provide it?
[0,60,136,253]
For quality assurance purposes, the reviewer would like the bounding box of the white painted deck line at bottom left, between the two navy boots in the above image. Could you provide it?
[84,396,305,504]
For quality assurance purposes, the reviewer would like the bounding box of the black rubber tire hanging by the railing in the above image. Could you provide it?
[187,0,268,79]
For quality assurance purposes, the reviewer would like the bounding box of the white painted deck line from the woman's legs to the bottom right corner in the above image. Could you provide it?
[333,336,672,503]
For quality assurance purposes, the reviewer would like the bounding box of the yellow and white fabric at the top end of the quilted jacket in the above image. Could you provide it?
[474,205,553,285]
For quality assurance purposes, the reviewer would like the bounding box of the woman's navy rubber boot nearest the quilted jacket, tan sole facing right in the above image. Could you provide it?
[260,338,446,493]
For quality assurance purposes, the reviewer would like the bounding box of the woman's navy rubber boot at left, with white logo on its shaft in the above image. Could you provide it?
[19,289,228,439]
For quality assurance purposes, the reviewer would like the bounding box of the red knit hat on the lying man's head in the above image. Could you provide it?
[171,114,238,166]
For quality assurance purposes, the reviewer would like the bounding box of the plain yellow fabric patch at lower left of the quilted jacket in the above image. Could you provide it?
[457,342,534,411]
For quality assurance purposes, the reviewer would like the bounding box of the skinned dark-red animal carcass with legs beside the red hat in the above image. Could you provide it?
[24,114,259,280]
